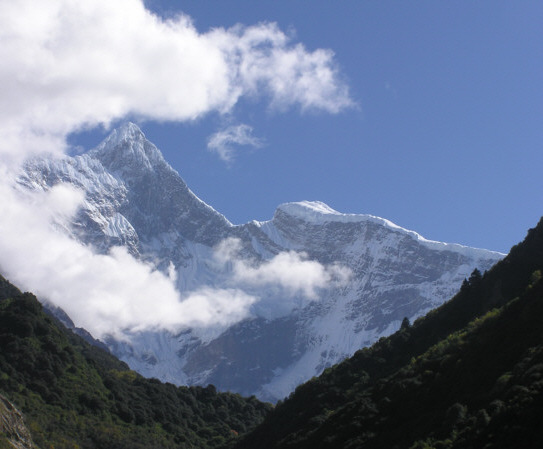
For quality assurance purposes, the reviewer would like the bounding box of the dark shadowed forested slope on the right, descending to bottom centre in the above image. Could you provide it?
[235,216,543,449]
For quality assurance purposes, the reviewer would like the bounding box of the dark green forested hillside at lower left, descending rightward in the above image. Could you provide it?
[0,276,271,449]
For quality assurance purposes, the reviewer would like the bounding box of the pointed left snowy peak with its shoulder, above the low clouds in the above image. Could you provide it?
[19,123,231,257]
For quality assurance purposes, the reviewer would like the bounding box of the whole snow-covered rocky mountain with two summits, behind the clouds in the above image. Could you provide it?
[20,123,503,400]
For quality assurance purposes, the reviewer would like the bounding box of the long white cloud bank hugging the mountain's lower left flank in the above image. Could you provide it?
[0,175,257,338]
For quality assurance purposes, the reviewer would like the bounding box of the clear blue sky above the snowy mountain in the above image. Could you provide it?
[66,0,543,252]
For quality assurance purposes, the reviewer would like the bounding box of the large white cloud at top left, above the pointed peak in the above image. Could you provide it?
[0,0,352,164]
